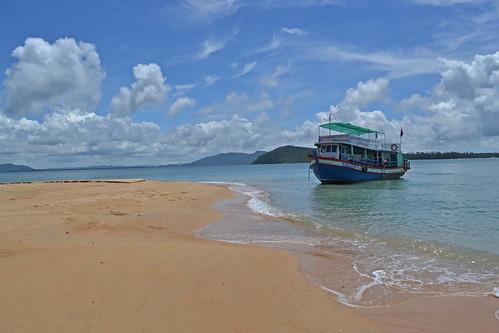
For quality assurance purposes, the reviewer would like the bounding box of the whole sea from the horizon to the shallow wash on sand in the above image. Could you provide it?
[0,158,499,307]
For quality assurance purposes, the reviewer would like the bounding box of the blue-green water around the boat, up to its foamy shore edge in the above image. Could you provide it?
[0,159,499,304]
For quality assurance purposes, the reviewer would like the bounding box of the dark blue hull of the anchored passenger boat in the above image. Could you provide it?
[310,162,405,184]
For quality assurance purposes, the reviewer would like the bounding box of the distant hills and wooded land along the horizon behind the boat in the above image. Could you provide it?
[0,146,499,172]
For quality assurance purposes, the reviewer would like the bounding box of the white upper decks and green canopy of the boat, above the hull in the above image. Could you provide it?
[315,122,404,167]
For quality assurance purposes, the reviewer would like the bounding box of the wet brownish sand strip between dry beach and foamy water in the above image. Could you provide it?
[198,187,499,333]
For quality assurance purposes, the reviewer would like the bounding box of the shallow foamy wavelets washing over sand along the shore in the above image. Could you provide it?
[199,182,499,307]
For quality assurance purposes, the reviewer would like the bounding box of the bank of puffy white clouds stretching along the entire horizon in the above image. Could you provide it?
[0,38,499,167]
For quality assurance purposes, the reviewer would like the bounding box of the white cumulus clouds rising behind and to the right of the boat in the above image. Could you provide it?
[326,52,499,151]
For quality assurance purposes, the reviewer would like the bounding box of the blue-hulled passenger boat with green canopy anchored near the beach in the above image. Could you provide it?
[309,122,411,184]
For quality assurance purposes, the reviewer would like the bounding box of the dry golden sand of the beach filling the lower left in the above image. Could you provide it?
[0,181,380,332]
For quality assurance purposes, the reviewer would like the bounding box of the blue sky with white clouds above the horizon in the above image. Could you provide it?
[0,0,499,168]
